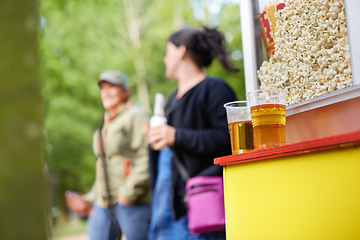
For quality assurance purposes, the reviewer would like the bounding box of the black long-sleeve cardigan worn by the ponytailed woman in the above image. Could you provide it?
[150,76,236,219]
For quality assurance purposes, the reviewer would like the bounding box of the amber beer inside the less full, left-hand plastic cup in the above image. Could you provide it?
[229,121,254,154]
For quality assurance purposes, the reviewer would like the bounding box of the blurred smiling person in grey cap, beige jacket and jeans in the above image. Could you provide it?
[66,71,151,240]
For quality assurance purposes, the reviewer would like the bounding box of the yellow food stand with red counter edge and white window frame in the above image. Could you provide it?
[214,0,360,240]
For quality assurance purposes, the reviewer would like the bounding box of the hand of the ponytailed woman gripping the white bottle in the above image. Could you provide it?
[148,124,176,151]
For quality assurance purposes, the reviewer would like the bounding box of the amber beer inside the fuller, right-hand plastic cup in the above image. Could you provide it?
[251,104,286,149]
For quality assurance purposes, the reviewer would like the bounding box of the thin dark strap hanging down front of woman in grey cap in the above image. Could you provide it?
[99,127,122,240]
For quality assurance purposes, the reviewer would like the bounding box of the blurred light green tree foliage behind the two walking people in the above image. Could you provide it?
[40,0,244,225]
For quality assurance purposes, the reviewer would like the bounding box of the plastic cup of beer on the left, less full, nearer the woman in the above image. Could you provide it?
[224,101,254,154]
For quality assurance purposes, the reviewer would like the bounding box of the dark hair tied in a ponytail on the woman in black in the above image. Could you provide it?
[169,27,239,72]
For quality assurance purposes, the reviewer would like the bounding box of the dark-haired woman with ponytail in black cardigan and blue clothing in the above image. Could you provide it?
[148,27,238,240]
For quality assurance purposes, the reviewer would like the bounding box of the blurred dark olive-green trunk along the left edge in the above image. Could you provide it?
[0,0,50,237]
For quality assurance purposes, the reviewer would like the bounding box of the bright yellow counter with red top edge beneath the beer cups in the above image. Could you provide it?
[214,131,360,240]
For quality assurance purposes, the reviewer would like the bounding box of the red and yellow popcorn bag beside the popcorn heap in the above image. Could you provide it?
[259,1,285,59]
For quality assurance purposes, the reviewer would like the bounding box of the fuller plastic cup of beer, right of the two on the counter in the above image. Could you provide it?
[246,89,286,150]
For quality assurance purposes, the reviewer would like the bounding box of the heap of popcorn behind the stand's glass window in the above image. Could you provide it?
[258,0,352,105]
